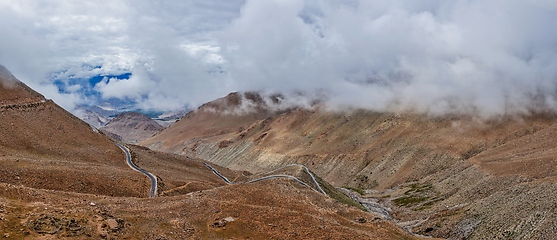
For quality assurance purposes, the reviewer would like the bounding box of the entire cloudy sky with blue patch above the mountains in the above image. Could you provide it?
[0,0,557,116]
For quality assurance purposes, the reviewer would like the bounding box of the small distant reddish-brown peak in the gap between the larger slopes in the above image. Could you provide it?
[100,112,164,143]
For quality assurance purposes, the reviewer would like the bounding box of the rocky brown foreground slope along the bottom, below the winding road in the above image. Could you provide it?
[0,180,423,240]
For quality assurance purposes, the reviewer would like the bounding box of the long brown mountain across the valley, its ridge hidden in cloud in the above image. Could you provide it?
[141,93,557,239]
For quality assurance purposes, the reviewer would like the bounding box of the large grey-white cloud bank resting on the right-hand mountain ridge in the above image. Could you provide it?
[219,1,557,115]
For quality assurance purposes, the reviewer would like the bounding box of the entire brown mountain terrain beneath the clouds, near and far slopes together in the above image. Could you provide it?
[0,62,557,239]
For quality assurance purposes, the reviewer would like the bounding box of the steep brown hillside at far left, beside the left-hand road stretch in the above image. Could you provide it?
[0,67,150,196]
